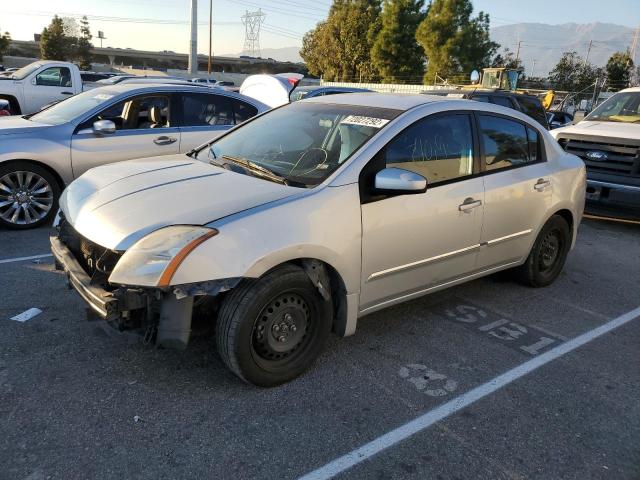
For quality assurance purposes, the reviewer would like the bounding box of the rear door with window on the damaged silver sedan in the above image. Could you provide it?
[476,112,553,270]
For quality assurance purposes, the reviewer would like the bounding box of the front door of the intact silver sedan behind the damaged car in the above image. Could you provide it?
[71,94,180,177]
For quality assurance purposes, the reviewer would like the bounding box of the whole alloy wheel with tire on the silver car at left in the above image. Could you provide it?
[0,162,60,229]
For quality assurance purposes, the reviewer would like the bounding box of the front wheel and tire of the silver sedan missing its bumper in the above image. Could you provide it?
[216,265,332,387]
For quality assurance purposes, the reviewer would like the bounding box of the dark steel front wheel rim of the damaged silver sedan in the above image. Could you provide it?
[251,292,313,367]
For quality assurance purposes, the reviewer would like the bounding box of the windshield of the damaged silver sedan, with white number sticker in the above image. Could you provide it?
[198,102,402,187]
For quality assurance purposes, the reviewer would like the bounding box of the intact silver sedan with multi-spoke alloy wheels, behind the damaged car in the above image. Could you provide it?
[0,82,269,228]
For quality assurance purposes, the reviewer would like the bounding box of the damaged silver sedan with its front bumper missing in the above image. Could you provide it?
[51,93,585,386]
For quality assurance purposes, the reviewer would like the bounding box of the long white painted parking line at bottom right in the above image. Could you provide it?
[299,307,640,480]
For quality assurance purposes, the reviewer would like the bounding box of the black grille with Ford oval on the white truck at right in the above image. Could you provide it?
[560,139,640,176]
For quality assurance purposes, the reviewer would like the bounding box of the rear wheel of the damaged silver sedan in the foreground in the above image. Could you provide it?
[514,215,571,287]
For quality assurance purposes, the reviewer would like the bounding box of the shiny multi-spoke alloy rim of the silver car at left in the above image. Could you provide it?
[0,170,53,225]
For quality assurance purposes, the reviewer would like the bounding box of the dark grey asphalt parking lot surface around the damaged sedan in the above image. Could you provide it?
[0,220,640,480]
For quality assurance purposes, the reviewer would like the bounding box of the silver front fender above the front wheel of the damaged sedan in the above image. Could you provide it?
[172,184,362,293]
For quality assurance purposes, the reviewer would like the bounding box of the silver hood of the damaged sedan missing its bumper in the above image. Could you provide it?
[60,155,300,250]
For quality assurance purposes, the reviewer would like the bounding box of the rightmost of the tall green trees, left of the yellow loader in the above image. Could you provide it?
[416,0,498,83]
